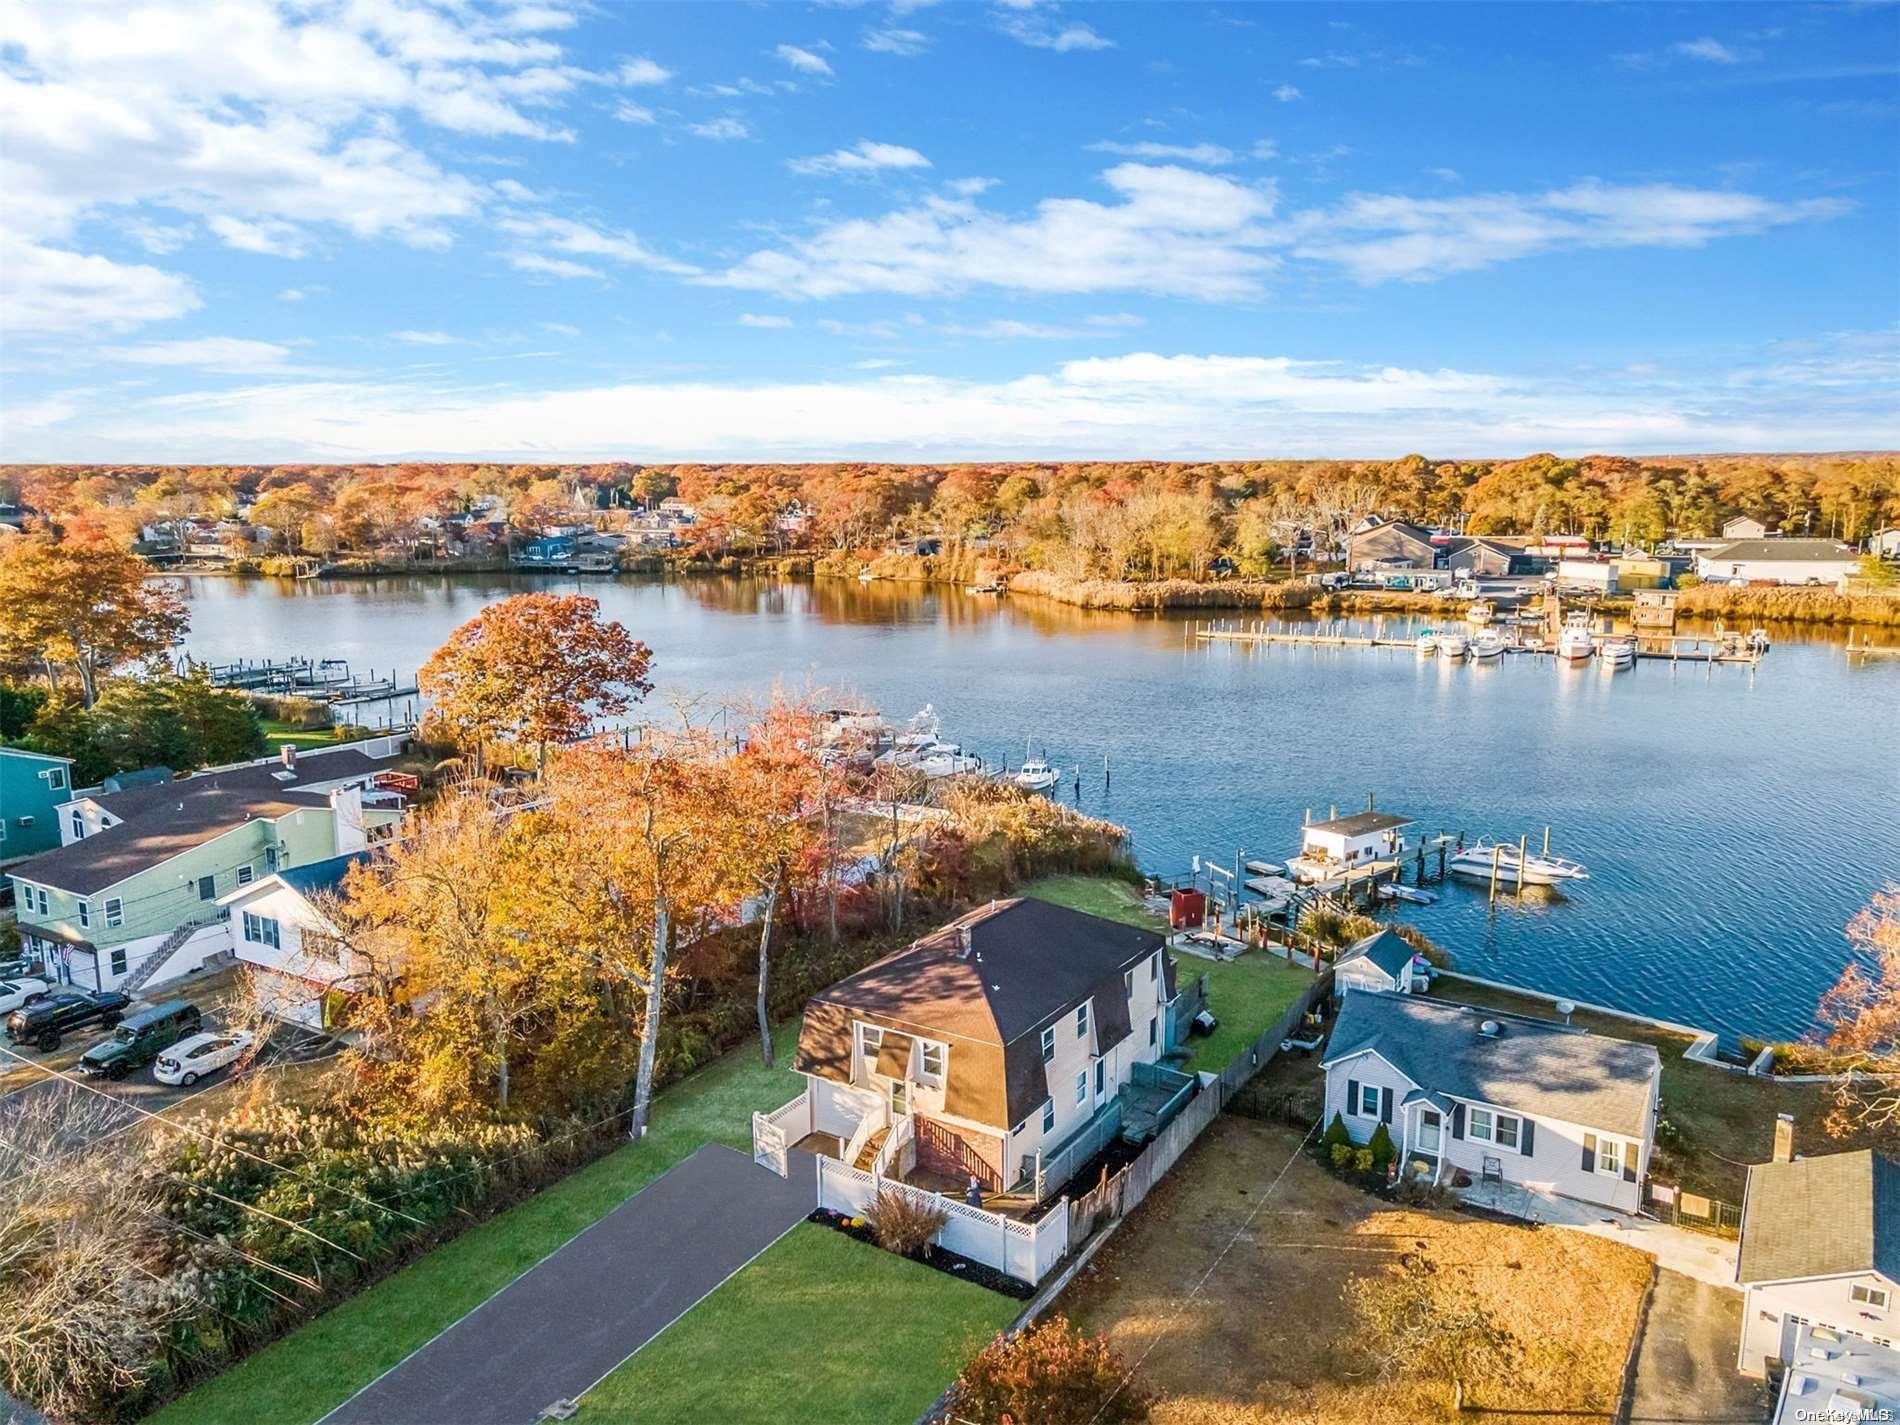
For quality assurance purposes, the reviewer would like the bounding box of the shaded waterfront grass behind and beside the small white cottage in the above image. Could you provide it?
[1433,979,1868,1205]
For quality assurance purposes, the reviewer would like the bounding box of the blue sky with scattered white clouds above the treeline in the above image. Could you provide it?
[0,0,1900,460]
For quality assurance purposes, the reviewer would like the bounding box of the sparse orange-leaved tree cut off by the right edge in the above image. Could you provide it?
[1818,884,1900,1140]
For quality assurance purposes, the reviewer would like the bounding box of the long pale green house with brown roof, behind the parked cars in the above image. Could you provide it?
[8,737,403,992]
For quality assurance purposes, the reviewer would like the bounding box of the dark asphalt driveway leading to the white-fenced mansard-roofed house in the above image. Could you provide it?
[319,1144,815,1425]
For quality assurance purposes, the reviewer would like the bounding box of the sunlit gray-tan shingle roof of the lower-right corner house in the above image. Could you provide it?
[1735,1150,1900,1283]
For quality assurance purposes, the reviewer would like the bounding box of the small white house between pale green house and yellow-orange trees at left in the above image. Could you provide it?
[219,851,369,1030]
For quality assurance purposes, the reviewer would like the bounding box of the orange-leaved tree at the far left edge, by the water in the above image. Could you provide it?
[0,532,188,707]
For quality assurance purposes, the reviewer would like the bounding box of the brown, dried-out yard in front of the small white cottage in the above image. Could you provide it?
[1058,1115,1651,1425]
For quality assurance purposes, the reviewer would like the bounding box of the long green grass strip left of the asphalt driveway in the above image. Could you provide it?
[148,1020,801,1425]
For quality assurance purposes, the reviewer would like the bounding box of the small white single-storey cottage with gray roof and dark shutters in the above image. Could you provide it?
[1322,990,1663,1212]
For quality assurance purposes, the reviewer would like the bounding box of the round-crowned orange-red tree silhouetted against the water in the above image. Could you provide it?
[416,593,654,771]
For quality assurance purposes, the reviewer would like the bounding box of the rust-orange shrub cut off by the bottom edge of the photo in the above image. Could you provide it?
[950,1317,1153,1425]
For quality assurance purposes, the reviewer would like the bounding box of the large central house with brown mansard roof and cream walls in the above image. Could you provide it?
[794,899,1188,1191]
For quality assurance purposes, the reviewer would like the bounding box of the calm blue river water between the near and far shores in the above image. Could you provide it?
[178,576,1900,1036]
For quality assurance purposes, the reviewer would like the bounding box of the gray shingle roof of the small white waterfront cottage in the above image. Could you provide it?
[1326,988,1663,1138]
